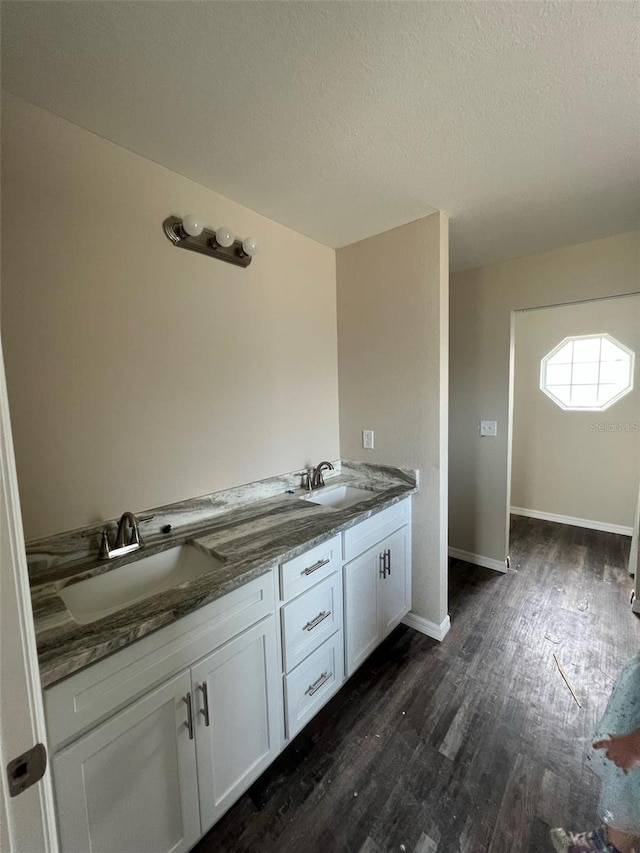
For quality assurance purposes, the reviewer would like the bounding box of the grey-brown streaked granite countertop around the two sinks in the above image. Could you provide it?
[32,463,417,687]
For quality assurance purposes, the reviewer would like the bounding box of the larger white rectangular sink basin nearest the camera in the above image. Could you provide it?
[58,545,222,625]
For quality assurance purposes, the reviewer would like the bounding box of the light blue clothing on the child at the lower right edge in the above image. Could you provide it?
[590,653,640,836]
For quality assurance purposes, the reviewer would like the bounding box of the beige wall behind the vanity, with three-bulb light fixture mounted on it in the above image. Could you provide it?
[2,95,339,538]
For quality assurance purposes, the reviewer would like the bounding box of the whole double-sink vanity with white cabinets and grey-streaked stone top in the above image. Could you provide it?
[28,463,417,853]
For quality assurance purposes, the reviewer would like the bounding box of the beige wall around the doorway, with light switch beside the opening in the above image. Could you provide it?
[449,232,640,561]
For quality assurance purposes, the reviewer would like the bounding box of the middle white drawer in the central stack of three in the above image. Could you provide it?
[281,572,342,672]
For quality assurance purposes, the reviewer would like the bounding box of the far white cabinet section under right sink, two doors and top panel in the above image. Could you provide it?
[343,500,411,677]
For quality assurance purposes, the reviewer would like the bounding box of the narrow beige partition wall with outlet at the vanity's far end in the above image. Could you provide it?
[337,213,449,625]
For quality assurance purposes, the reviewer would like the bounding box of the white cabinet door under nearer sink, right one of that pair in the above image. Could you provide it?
[191,615,281,832]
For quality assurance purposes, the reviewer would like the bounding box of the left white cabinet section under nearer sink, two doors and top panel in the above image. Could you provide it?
[45,572,281,853]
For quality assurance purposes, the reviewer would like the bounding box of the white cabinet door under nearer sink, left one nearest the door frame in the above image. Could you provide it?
[53,672,200,853]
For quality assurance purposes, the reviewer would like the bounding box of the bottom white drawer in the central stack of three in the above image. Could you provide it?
[284,631,344,739]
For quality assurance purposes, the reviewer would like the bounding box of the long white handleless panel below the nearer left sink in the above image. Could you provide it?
[43,572,275,748]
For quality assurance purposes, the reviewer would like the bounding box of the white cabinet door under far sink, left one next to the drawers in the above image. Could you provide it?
[343,548,382,676]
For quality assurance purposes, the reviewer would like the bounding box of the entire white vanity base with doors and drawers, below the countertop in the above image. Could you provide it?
[44,490,411,853]
